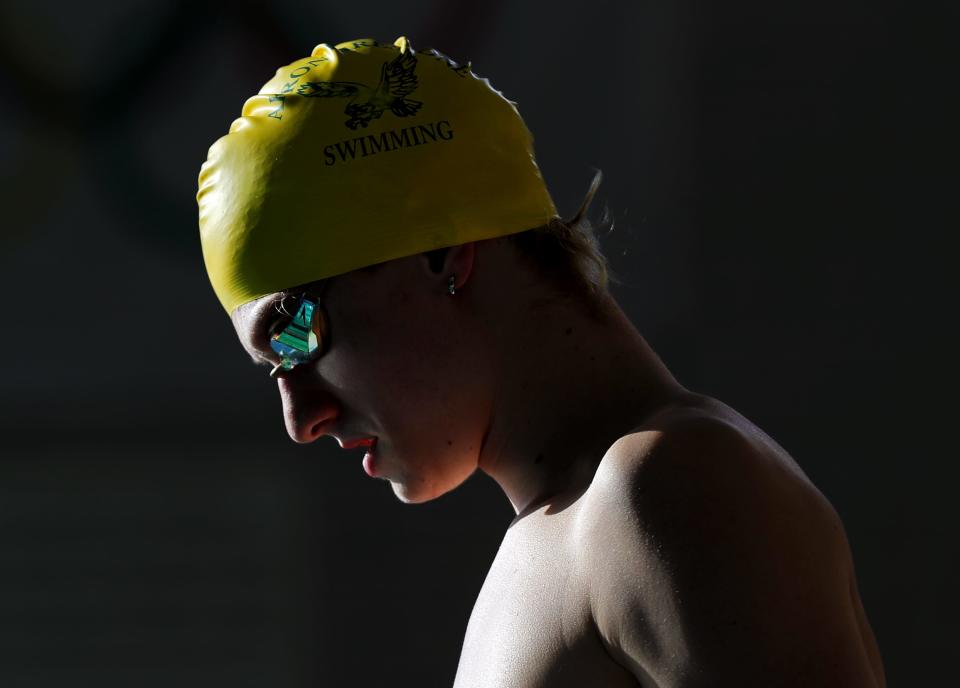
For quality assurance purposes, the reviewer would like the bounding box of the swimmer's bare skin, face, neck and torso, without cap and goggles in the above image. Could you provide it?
[233,240,885,688]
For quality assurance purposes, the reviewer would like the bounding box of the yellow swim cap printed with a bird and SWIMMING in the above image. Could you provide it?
[197,38,556,313]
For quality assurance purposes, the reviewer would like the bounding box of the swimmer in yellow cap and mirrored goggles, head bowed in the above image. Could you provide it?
[197,38,885,688]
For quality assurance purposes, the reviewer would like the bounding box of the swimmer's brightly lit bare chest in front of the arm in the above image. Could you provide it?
[455,509,637,688]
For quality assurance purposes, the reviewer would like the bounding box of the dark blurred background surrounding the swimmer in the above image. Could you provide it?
[0,0,960,688]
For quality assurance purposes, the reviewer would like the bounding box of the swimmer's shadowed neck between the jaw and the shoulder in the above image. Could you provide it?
[479,284,685,517]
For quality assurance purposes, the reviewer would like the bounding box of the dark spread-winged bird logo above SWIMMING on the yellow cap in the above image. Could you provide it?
[297,50,423,129]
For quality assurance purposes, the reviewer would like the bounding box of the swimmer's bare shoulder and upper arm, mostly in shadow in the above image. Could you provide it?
[577,400,877,686]
